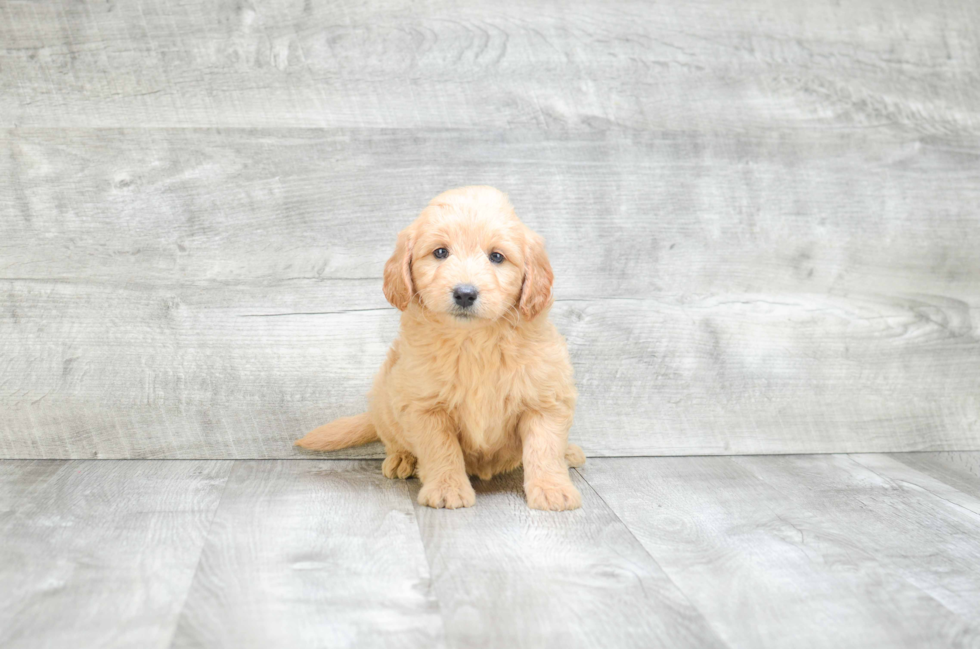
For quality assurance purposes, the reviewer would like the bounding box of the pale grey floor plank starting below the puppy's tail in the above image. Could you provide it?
[172,461,443,648]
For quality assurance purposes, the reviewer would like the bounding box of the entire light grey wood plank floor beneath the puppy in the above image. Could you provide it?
[0,453,980,649]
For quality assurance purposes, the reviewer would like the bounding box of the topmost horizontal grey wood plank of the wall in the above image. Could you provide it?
[0,0,980,133]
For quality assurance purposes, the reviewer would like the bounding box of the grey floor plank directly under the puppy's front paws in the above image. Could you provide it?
[410,471,724,649]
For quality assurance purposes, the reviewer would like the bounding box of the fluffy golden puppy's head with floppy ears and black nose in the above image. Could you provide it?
[384,187,554,326]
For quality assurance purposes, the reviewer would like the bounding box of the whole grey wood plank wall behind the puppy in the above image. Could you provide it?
[0,0,980,458]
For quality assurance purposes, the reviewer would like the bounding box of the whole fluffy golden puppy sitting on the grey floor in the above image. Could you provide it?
[296,187,585,510]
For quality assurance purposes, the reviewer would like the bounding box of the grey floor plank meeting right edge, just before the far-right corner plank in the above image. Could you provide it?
[732,455,980,628]
